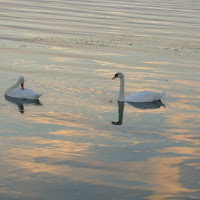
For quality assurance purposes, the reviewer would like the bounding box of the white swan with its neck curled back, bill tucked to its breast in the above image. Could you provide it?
[5,76,42,99]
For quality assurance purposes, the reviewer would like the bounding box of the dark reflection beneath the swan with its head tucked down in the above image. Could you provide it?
[5,96,42,113]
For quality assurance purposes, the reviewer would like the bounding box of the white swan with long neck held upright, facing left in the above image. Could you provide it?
[112,72,165,102]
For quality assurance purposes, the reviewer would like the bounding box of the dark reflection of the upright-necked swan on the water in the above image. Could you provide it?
[112,100,165,125]
